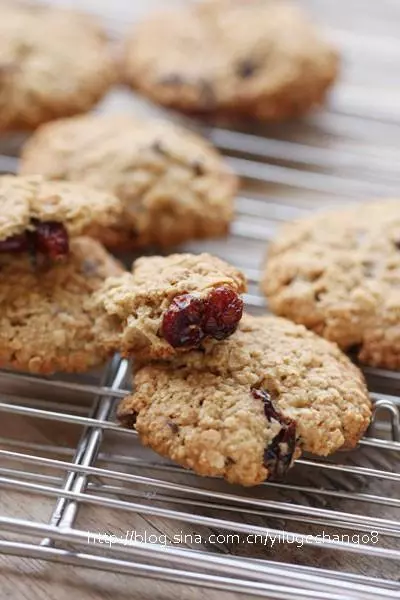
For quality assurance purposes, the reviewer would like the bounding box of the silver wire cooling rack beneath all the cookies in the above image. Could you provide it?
[0,1,400,600]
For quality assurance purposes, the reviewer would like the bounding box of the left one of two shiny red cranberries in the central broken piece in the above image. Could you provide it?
[161,294,205,348]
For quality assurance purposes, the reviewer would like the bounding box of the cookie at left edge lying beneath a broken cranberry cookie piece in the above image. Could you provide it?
[0,237,122,373]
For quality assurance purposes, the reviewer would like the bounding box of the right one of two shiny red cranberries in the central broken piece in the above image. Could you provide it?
[203,286,243,340]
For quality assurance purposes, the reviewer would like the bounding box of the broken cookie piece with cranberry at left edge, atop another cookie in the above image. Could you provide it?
[0,175,122,259]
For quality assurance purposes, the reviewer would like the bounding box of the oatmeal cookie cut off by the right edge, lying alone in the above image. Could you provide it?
[262,200,400,369]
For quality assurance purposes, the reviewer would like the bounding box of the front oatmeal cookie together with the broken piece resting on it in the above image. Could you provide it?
[88,254,371,485]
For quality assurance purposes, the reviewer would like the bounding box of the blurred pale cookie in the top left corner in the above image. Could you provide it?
[0,2,115,130]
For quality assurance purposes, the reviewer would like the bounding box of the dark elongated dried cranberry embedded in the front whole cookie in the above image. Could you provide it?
[251,388,296,479]
